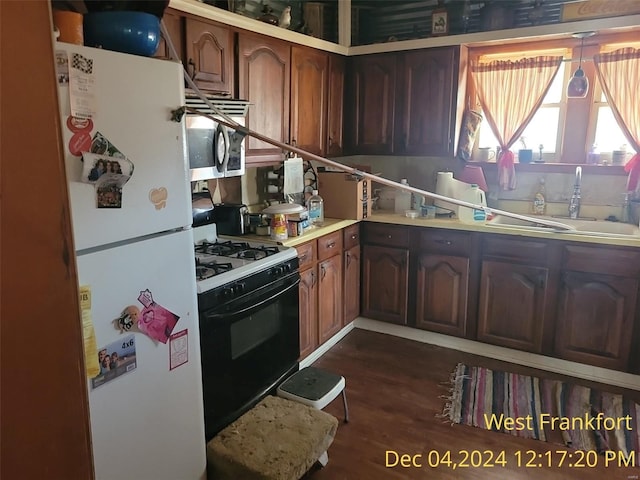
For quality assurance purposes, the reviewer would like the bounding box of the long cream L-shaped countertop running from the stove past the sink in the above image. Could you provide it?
[222,210,640,248]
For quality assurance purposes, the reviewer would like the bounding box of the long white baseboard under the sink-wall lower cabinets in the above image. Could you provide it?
[352,317,640,391]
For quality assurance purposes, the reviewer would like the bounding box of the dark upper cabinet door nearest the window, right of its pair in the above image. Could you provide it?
[395,47,458,156]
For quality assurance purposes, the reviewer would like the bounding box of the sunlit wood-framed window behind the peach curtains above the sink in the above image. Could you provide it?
[469,34,640,164]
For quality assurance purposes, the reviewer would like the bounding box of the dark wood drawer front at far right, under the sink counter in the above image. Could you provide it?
[563,245,640,277]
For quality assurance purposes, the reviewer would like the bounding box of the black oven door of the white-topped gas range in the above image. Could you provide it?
[200,272,300,440]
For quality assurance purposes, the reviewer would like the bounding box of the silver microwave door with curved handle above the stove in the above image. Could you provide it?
[186,115,229,182]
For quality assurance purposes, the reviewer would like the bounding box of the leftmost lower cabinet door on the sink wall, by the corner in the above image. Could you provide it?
[362,245,409,325]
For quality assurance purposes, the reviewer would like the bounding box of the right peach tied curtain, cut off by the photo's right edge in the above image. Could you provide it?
[593,48,640,191]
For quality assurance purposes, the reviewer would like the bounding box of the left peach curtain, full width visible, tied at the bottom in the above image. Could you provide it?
[470,56,562,190]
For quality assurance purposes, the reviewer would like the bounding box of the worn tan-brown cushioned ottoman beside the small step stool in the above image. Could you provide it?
[207,396,338,480]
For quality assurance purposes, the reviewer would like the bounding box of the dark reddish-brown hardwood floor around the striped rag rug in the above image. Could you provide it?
[305,329,640,480]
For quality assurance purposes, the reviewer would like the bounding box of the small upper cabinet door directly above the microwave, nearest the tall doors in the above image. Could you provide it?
[185,18,234,95]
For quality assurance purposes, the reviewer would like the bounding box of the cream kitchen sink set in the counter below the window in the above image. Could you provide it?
[487,215,640,238]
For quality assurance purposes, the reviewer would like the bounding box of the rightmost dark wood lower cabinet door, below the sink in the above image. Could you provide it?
[555,272,638,370]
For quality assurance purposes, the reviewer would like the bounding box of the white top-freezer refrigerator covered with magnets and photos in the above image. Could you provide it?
[56,43,206,480]
